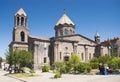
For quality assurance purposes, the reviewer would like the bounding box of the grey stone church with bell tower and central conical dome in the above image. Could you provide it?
[9,8,119,69]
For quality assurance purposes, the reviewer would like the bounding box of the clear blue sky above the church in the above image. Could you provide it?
[0,0,120,58]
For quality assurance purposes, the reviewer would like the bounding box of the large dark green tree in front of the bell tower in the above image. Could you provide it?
[6,50,33,67]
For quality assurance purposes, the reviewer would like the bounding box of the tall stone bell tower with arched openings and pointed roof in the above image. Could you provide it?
[10,8,29,50]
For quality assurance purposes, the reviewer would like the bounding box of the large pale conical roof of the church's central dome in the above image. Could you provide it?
[56,13,74,25]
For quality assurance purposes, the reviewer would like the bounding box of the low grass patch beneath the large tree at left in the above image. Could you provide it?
[8,73,39,78]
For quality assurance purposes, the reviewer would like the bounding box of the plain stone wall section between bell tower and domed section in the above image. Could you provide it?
[33,41,50,69]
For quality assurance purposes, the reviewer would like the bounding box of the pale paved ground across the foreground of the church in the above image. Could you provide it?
[0,71,120,82]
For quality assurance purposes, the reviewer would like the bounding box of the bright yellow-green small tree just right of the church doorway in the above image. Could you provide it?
[69,54,80,72]
